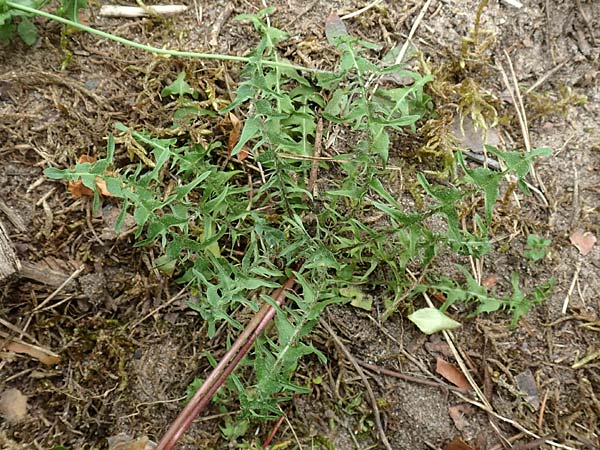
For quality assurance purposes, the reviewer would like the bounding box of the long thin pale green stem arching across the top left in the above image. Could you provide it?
[6,1,330,73]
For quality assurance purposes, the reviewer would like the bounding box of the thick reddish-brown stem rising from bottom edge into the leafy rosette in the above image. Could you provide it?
[155,276,295,450]
